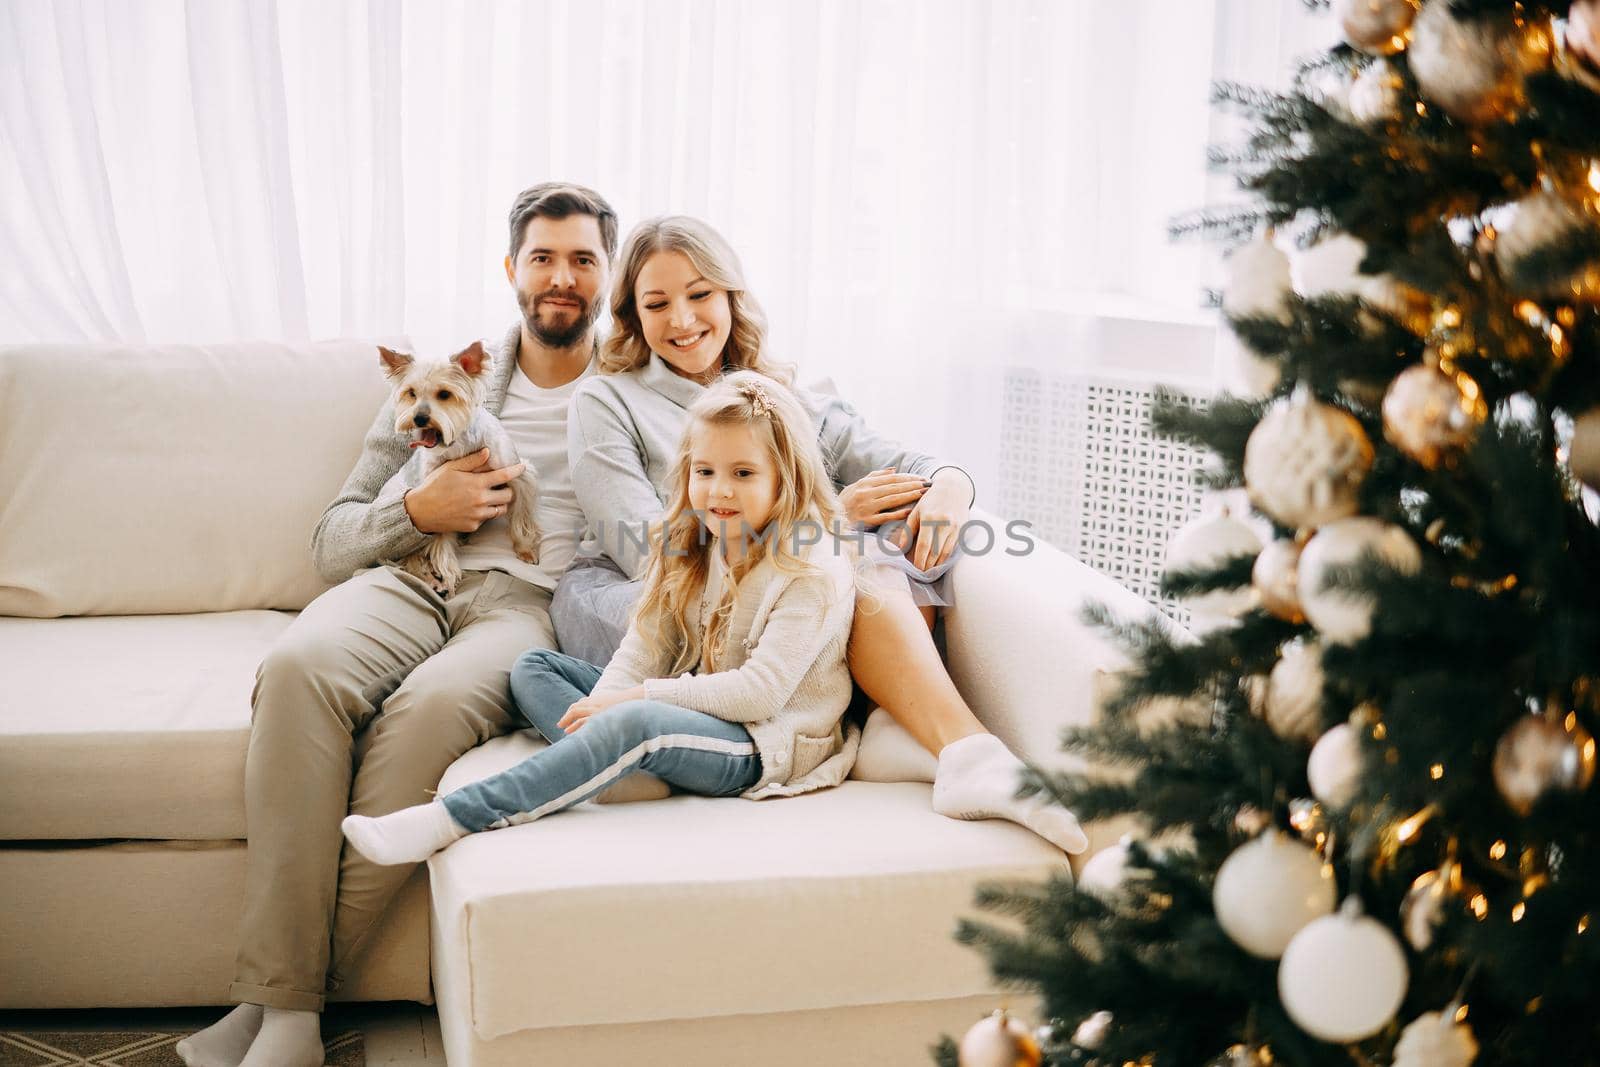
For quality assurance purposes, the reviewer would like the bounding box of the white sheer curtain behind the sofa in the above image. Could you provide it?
[0,0,1324,489]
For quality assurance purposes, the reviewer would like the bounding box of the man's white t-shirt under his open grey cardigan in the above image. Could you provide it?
[456,360,595,590]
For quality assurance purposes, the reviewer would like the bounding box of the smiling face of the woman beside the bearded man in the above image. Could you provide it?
[634,251,733,386]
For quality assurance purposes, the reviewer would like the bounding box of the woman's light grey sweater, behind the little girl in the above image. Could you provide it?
[566,354,939,577]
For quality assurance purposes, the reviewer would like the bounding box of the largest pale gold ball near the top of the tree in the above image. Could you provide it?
[1406,0,1552,123]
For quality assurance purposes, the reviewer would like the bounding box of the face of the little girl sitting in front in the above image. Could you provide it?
[690,424,778,560]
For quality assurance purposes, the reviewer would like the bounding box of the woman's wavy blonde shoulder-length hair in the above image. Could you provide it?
[600,214,794,386]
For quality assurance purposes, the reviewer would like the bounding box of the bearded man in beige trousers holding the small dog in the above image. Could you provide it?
[178,182,616,1067]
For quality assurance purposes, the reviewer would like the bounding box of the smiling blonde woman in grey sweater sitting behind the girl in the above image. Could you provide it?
[550,216,1088,851]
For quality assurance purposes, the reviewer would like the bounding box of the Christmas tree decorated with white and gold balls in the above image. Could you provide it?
[938,0,1600,1067]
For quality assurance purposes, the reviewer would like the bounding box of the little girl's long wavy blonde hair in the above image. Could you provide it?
[634,371,842,675]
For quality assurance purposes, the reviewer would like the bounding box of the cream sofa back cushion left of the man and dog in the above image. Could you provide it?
[0,341,395,617]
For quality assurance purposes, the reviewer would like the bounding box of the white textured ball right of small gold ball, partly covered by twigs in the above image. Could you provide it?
[1299,515,1422,645]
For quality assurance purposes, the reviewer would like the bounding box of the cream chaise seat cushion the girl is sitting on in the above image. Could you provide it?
[429,734,1066,1040]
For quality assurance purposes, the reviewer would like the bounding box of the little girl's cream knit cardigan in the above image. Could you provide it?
[594,537,861,800]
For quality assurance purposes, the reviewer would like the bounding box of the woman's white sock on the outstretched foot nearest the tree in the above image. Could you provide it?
[933,734,1090,853]
